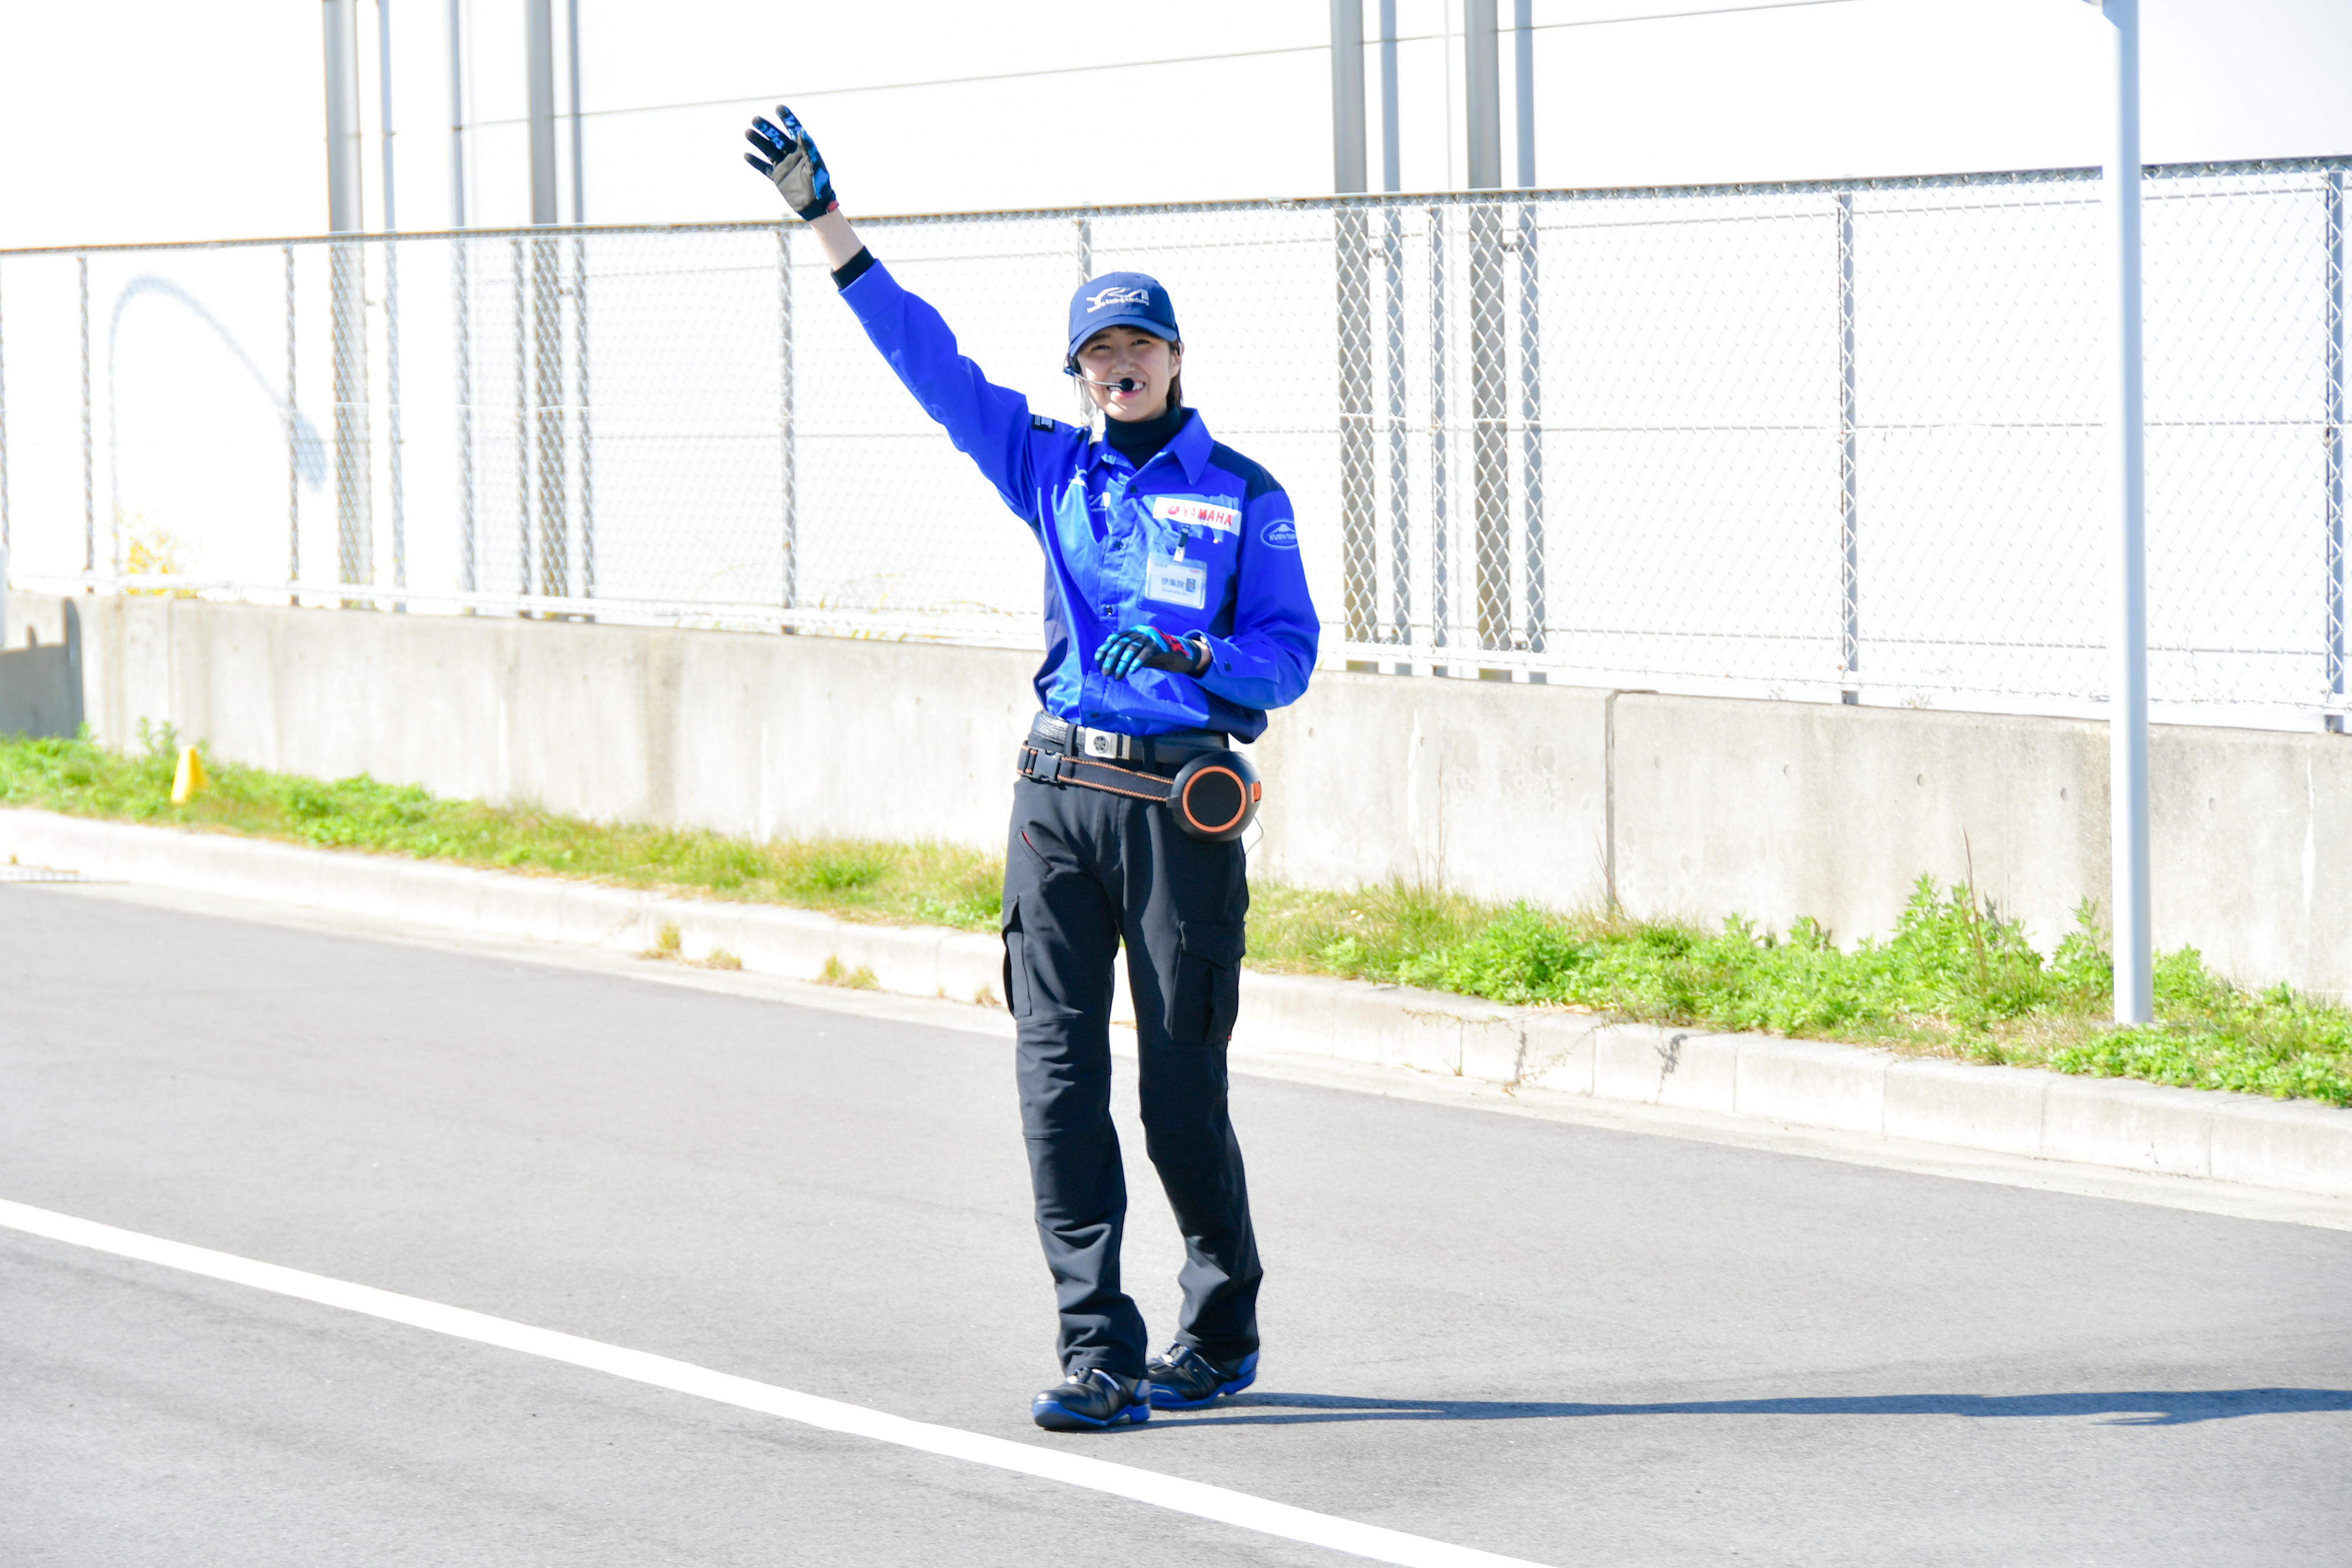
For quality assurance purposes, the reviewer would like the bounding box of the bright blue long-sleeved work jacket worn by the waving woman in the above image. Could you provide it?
[842,263,1322,741]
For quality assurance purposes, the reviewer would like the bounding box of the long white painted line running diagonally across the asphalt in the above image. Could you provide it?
[0,1199,1541,1568]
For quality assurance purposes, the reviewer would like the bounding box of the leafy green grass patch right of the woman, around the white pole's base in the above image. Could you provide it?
[1249,877,2352,1105]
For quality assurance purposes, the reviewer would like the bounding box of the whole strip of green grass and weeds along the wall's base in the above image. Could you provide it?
[0,731,2352,1105]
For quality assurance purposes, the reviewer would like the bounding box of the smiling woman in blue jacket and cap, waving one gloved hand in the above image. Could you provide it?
[748,106,1317,1432]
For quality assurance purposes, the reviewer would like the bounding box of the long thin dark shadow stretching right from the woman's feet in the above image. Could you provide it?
[1185,1389,2352,1427]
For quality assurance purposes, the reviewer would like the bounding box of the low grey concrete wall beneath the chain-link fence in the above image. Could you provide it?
[14,595,2352,992]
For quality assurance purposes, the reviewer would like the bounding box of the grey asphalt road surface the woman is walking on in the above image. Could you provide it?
[14,886,2352,1568]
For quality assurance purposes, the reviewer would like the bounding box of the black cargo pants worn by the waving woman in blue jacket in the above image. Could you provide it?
[1004,778,1261,1378]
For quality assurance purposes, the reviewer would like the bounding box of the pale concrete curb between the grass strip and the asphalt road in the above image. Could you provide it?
[0,808,2352,1196]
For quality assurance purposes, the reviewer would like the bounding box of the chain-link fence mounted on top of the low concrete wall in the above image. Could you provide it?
[0,158,2352,724]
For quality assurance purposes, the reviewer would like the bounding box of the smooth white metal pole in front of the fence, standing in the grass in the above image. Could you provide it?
[2098,0,2154,1022]
